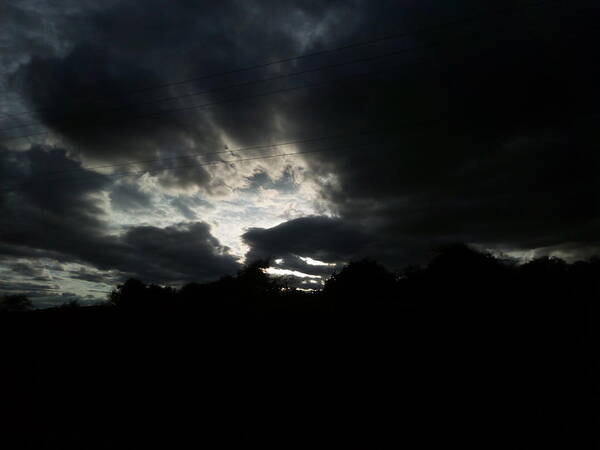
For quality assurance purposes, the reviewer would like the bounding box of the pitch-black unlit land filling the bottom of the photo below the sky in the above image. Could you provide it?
[0,248,599,449]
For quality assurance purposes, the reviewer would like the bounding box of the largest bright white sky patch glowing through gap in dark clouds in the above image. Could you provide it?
[110,157,323,262]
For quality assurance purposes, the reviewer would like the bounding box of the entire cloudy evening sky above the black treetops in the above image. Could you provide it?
[0,0,600,306]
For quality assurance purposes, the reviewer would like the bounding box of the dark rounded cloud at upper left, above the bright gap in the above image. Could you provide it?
[9,42,221,193]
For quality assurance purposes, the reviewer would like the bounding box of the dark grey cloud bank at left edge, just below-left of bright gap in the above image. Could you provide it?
[0,147,238,282]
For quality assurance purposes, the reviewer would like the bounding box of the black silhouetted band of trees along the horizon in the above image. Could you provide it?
[0,244,600,316]
